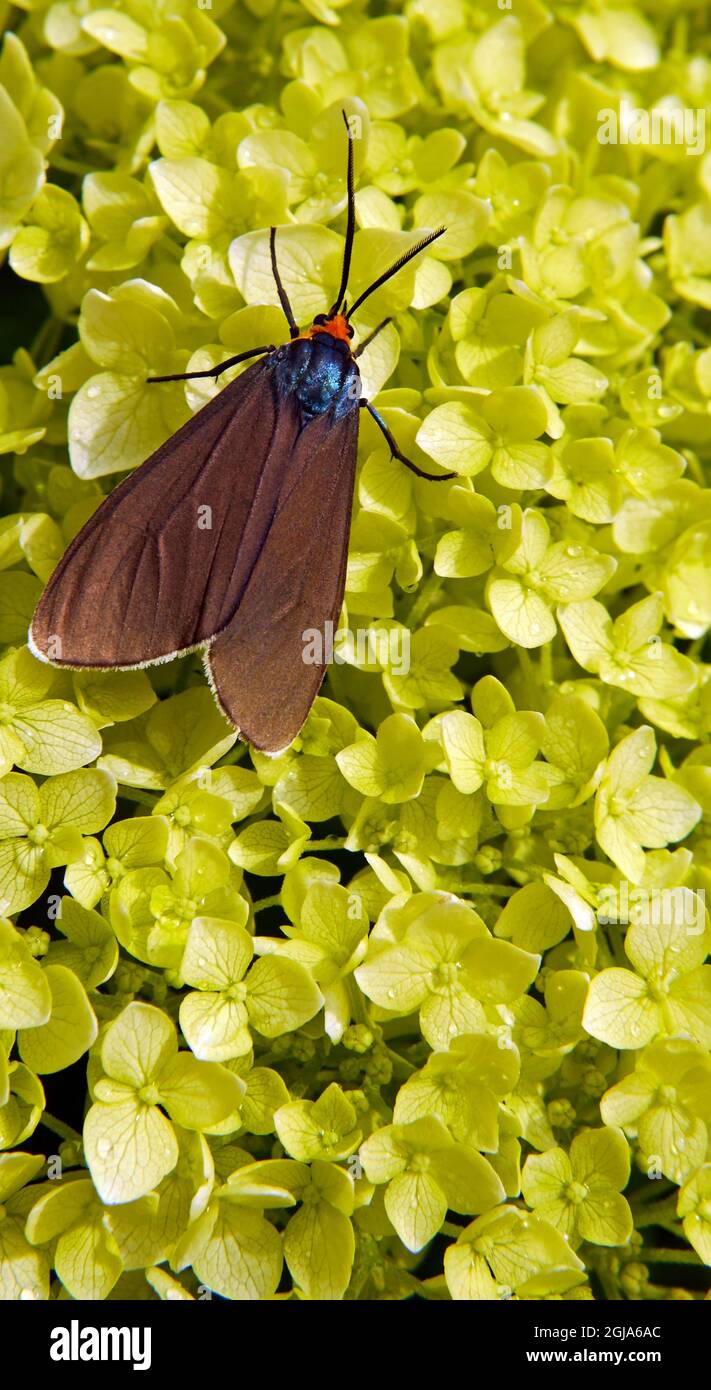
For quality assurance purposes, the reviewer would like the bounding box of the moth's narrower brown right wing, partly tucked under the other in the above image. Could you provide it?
[207,409,358,752]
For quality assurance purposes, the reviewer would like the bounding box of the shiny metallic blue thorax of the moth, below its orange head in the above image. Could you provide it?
[272,334,361,420]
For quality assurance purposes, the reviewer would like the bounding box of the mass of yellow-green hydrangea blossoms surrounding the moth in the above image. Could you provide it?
[0,0,711,1300]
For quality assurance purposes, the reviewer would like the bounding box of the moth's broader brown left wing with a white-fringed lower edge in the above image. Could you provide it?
[31,359,300,669]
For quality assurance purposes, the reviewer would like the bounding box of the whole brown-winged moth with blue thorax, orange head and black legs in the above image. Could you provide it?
[29,113,453,752]
